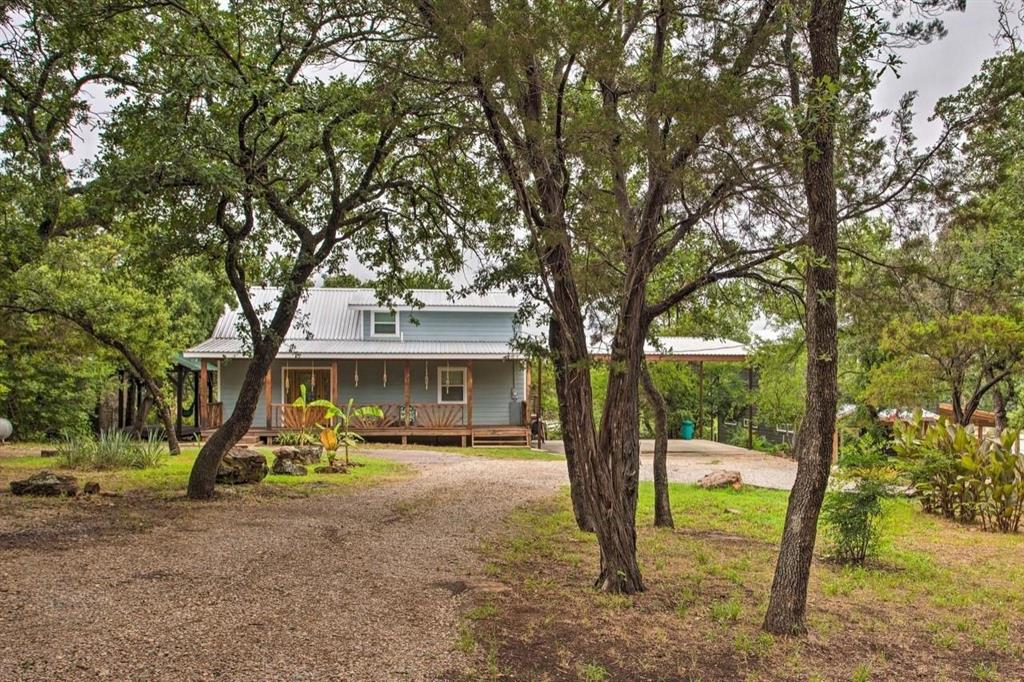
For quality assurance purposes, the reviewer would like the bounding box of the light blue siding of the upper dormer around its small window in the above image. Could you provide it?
[361,310,514,341]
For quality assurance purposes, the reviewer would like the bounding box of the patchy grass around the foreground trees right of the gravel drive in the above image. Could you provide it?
[466,483,1024,680]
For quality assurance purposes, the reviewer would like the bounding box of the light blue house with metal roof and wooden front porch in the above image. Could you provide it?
[184,289,529,444]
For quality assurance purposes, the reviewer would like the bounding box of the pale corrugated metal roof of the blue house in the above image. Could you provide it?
[183,288,519,359]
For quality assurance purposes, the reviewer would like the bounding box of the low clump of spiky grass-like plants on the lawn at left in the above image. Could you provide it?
[57,430,167,470]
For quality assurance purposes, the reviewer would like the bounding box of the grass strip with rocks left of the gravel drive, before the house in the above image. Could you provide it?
[0,440,412,494]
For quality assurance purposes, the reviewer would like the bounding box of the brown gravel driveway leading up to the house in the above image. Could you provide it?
[0,451,565,680]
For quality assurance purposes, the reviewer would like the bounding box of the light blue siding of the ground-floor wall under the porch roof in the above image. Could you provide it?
[220,359,526,427]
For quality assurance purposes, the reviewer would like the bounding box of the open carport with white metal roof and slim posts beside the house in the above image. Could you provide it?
[592,336,755,447]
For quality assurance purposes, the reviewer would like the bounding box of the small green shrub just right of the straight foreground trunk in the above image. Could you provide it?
[821,434,896,564]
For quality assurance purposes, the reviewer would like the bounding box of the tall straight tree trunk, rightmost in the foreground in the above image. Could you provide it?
[764,0,845,635]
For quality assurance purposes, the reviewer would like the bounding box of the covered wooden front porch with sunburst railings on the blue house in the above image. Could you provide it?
[194,357,529,446]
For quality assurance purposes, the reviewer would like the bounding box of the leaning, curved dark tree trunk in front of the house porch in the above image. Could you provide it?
[188,274,316,493]
